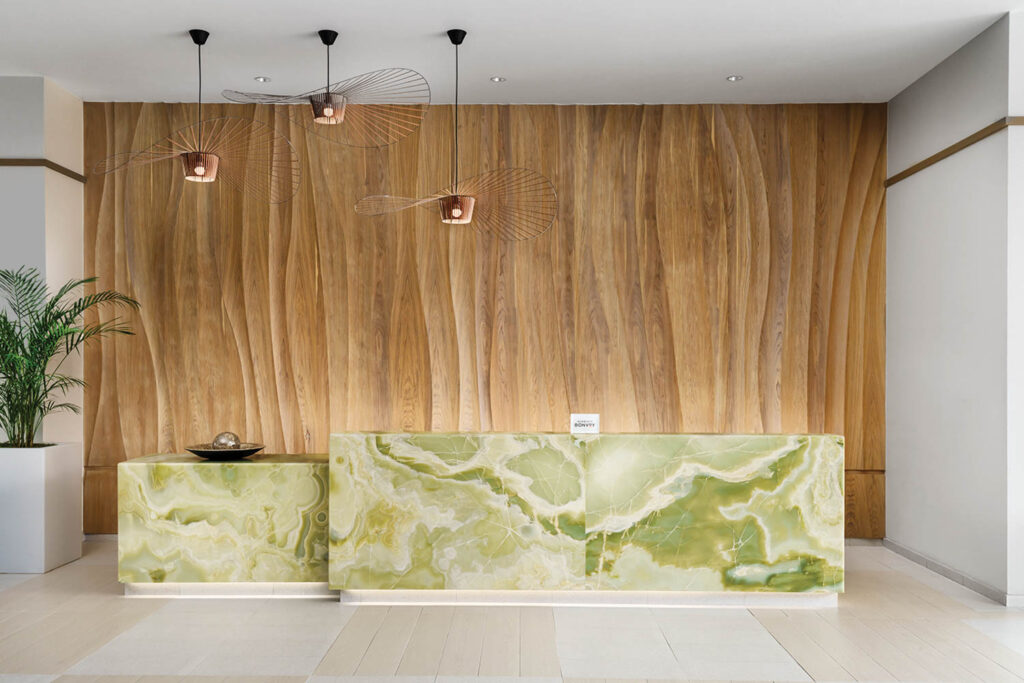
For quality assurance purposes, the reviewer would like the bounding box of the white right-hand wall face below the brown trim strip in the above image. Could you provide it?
[886,132,1007,592]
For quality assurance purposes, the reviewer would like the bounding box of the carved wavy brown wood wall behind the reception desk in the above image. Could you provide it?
[85,103,886,537]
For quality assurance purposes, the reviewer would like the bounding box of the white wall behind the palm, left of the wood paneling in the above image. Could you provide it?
[0,77,85,442]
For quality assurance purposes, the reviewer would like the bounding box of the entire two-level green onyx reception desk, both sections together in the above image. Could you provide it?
[118,433,844,604]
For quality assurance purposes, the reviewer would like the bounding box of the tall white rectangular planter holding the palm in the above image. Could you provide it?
[0,443,83,573]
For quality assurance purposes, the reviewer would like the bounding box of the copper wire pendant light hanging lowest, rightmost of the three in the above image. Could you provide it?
[355,29,558,240]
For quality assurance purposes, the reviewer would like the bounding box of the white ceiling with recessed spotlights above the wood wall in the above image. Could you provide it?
[0,0,1024,103]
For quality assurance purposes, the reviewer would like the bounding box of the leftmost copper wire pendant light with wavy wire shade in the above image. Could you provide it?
[93,29,302,204]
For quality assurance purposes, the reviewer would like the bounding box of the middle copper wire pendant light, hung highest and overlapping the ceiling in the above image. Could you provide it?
[221,29,430,147]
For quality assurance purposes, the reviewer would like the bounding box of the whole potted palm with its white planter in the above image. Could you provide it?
[0,267,138,573]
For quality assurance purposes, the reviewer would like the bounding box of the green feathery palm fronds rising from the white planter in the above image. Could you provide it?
[0,267,138,446]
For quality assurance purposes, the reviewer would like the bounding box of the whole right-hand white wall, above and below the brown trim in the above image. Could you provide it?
[886,12,1024,603]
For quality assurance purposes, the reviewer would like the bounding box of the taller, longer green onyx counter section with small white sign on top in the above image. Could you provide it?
[330,433,844,592]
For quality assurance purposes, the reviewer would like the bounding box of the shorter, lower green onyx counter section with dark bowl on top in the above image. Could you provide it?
[118,455,328,583]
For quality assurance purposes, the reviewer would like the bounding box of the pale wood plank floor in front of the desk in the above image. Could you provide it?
[0,541,1024,683]
